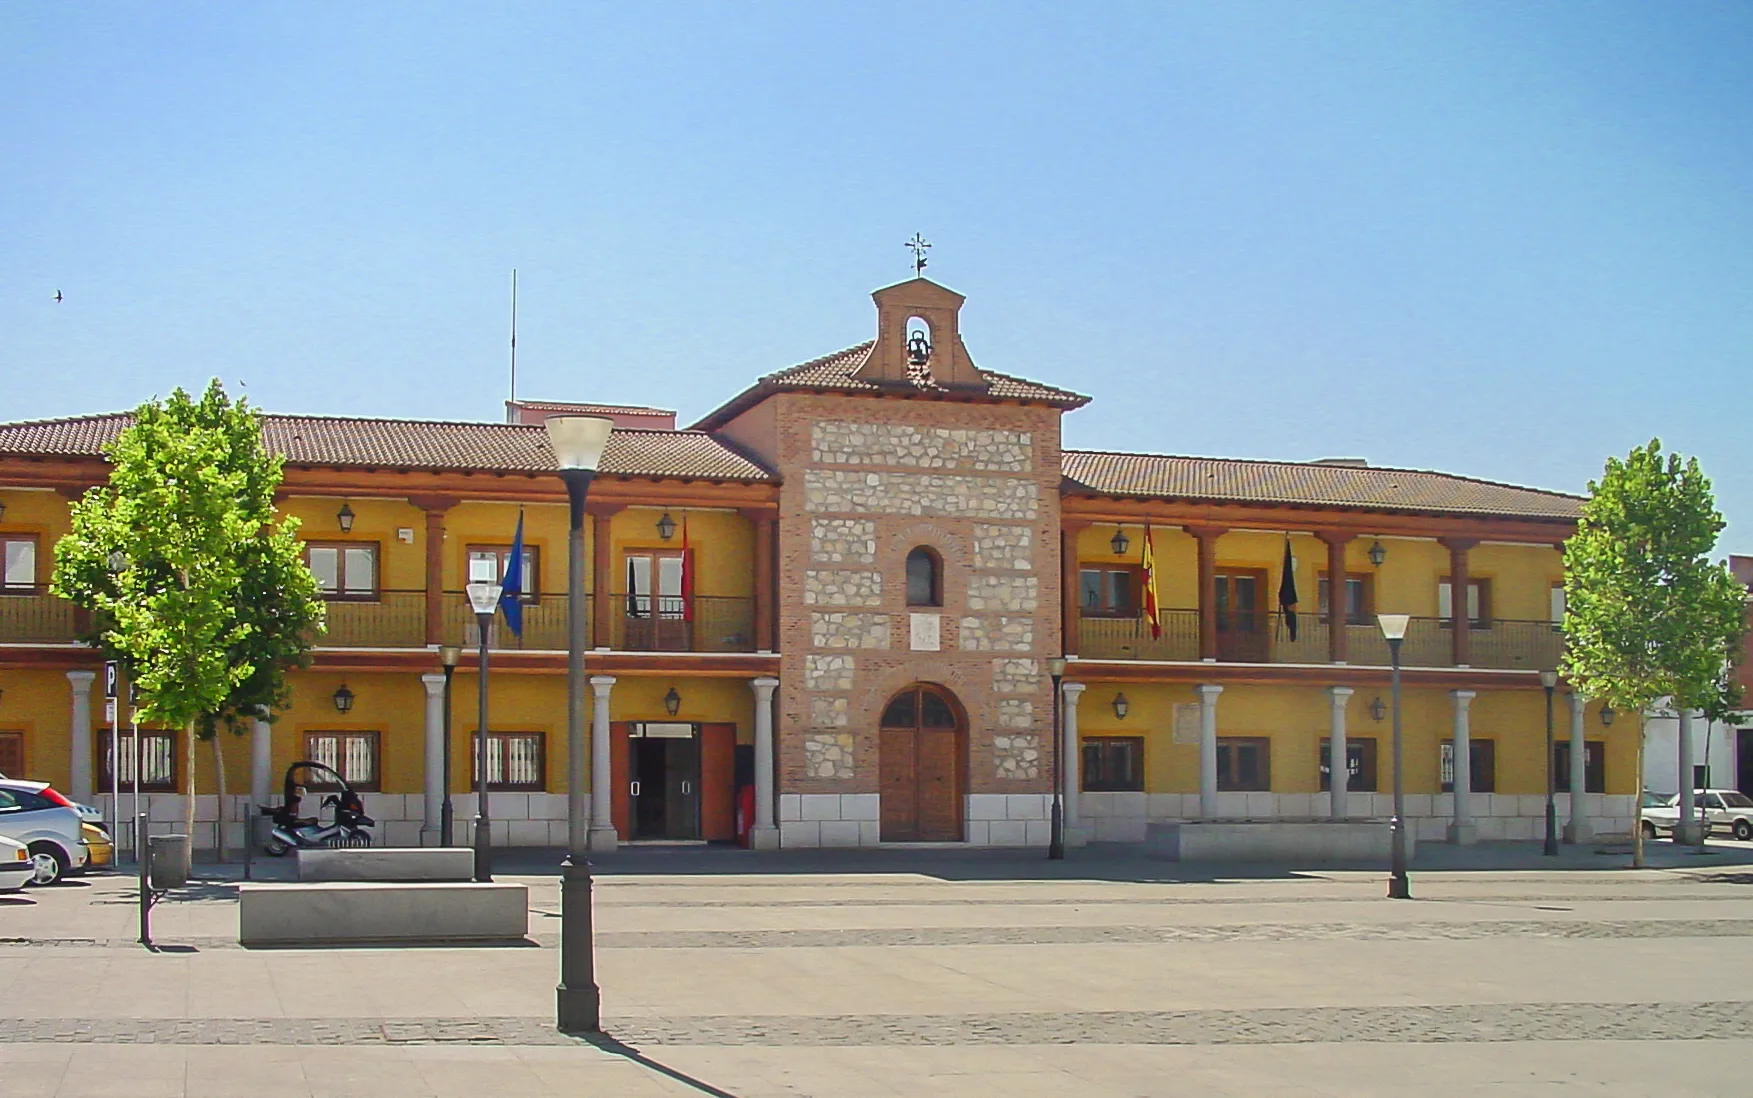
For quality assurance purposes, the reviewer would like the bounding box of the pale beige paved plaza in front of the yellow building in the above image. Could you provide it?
[0,844,1753,1098]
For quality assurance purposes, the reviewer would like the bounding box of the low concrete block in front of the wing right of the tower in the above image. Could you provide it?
[1145,819,1418,865]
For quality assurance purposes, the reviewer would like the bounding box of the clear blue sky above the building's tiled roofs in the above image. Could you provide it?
[0,0,1753,551]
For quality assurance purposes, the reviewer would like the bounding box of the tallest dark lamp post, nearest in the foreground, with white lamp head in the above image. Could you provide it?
[545,416,614,1033]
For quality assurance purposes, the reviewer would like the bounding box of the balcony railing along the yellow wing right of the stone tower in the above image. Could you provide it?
[1078,609,1564,670]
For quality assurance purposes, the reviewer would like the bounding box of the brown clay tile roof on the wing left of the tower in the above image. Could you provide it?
[0,412,773,481]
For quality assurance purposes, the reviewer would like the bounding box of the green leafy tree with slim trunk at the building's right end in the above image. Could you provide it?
[1564,438,1746,865]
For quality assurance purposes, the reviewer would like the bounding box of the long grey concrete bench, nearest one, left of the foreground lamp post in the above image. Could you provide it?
[237,881,529,945]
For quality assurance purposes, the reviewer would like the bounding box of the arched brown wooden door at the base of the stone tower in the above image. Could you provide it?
[878,682,968,842]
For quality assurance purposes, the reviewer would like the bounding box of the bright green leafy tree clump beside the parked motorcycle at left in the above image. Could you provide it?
[51,381,324,844]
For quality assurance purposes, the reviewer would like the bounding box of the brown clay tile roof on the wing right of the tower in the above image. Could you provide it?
[1062,451,1583,521]
